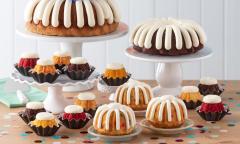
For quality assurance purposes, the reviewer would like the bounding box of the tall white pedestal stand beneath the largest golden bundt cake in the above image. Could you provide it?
[17,23,128,92]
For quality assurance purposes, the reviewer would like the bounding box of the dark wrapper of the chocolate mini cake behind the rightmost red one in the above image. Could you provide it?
[198,84,224,96]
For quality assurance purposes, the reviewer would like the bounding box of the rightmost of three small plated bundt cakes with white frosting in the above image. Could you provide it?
[146,95,188,128]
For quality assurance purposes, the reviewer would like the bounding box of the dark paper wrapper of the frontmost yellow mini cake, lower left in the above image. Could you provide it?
[30,125,61,136]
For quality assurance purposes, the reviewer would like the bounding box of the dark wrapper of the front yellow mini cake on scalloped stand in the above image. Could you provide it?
[31,72,59,83]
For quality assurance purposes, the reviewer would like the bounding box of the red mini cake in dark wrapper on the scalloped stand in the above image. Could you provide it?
[14,53,39,76]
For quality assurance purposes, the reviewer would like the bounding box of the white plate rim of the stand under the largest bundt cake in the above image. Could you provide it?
[16,22,129,43]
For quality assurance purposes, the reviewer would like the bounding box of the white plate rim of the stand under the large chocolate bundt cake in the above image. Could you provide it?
[124,46,213,63]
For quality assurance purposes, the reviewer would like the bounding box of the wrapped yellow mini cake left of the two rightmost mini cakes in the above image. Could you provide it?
[180,86,202,109]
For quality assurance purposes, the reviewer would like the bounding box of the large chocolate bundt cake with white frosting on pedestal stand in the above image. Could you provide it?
[130,18,206,56]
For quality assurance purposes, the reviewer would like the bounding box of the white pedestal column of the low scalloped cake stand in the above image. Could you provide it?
[43,86,70,114]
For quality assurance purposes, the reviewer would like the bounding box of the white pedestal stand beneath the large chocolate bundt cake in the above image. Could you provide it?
[125,47,213,96]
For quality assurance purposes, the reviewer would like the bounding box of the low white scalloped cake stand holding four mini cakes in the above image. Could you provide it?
[11,70,98,114]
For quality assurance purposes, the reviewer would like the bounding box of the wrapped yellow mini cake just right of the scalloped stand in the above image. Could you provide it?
[102,63,130,86]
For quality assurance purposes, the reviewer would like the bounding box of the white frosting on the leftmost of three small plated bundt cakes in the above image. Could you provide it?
[93,103,136,130]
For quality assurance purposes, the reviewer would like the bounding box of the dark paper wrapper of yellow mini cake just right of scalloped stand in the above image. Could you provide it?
[101,74,131,86]
